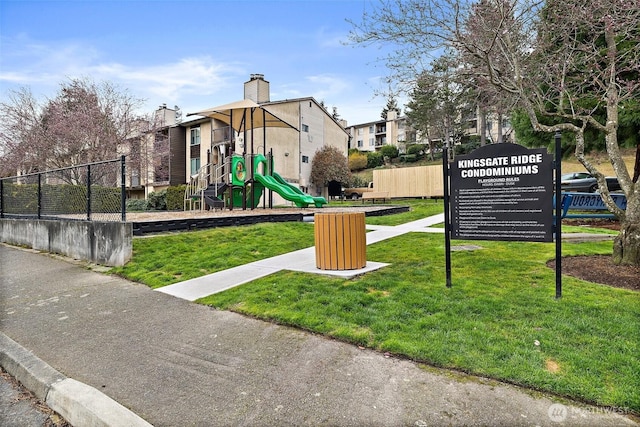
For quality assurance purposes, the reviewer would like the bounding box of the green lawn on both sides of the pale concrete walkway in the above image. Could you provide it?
[110,201,640,414]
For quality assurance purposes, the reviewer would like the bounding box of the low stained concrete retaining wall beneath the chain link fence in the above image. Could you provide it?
[0,219,133,266]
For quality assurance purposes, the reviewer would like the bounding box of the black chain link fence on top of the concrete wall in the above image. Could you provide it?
[0,156,126,222]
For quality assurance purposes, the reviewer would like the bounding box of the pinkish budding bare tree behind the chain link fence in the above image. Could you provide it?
[0,79,141,181]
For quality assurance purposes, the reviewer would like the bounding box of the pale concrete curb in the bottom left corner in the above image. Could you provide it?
[0,332,151,427]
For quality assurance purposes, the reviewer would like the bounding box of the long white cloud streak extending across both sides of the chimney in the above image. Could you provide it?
[0,34,384,123]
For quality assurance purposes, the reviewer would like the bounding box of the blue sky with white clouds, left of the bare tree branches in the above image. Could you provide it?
[0,0,400,124]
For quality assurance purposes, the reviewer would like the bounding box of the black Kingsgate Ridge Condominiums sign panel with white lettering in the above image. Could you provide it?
[450,144,553,242]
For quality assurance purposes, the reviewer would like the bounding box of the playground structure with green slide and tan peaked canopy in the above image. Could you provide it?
[184,100,327,210]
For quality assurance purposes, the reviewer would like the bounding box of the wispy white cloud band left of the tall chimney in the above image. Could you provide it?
[0,37,247,112]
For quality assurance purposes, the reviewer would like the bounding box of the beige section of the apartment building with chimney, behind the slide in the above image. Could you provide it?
[180,74,349,199]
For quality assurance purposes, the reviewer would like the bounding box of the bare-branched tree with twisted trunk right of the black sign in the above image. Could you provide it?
[351,0,640,265]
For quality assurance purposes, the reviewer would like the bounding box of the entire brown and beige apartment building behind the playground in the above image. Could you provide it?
[127,74,349,204]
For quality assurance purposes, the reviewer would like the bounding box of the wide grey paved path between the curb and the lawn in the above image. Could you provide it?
[0,245,634,427]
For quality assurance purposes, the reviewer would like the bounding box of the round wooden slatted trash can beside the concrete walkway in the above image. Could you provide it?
[314,212,367,270]
